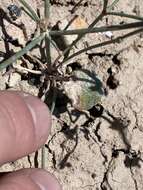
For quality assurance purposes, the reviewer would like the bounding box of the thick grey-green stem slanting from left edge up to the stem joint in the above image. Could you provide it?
[0,33,45,70]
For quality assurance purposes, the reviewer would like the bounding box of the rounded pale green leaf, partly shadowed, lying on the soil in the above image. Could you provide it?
[64,69,104,111]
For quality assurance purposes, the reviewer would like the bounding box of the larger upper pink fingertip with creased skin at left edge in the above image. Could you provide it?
[0,91,51,164]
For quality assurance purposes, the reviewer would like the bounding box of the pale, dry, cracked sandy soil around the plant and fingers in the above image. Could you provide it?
[0,0,143,190]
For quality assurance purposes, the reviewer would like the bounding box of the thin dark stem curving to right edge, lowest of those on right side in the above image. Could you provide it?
[61,28,143,65]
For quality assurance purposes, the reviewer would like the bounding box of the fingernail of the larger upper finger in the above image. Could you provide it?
[23,95,51,144]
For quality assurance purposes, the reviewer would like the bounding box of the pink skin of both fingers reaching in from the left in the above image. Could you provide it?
[0,91,61,190]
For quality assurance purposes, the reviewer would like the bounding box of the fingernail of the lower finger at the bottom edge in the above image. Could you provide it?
[31,170,61,190]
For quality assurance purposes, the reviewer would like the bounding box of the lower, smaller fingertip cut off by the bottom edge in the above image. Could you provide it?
[0,168,62,190]
